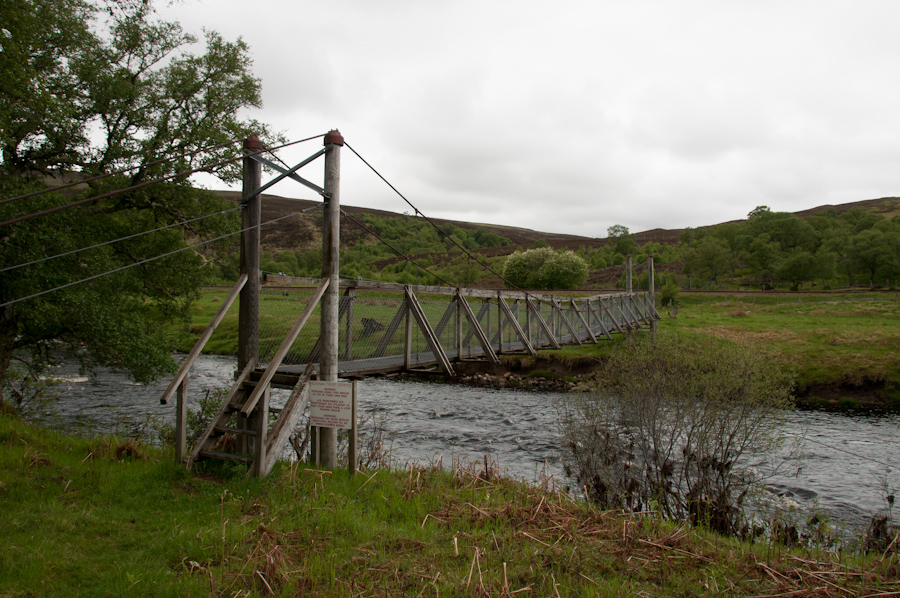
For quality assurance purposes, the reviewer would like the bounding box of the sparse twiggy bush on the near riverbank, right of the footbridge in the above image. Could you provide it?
[560,336,791,534]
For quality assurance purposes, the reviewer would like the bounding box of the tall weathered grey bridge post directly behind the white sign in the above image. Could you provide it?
[318,130,344,469]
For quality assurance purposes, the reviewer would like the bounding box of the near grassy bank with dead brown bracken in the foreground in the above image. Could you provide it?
[0,415,900,596]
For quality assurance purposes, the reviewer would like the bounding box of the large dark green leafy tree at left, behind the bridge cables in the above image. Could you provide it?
[0,0,267,408]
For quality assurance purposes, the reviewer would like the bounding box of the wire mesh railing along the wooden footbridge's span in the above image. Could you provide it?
[259,281,659,373]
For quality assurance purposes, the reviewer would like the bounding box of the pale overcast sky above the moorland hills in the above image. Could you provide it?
[162,0,900,237]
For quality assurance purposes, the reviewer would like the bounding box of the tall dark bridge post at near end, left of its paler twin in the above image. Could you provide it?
[237,135,262,372]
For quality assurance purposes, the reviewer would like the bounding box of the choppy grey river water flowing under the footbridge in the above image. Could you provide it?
[31,355,900,529]
